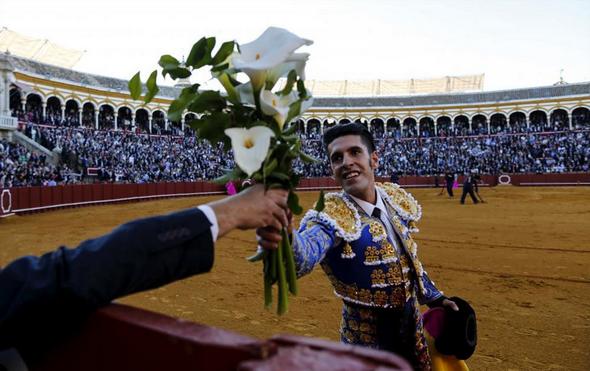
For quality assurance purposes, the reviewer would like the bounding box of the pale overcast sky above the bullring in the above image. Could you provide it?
[0,0,590,90]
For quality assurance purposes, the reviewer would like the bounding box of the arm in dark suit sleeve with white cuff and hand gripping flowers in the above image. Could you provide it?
[0,185,288,361]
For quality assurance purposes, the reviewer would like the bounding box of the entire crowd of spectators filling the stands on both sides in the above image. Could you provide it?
[0,117,590,186]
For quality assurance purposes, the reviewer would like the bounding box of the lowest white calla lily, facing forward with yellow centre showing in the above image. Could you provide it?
[225,126,275,176]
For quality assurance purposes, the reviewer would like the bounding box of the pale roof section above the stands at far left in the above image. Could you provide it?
[0,27,84,68]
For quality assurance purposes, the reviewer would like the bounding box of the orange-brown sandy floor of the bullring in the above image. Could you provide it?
[0,187,590,370]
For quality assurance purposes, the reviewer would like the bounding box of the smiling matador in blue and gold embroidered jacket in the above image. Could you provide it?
[258,123,457,370]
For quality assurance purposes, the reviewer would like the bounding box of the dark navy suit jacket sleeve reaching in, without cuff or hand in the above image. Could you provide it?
[0,209,213,348]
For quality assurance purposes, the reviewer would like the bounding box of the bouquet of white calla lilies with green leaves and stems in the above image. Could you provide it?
[129,27,315,314]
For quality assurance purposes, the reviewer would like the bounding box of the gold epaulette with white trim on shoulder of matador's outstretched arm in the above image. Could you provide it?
[301,192,361,242]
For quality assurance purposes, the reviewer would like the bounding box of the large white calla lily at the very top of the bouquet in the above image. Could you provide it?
[232,27,313,91]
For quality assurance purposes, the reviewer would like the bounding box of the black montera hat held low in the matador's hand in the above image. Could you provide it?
[435,296,477,359]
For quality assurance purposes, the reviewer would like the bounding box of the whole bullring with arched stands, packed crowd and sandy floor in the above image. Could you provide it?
[0,26,590,370]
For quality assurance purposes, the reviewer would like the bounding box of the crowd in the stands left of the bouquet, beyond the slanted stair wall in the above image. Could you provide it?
[24,127,233,183]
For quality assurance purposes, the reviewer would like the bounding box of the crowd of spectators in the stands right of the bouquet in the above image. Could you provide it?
[295,130,590,177]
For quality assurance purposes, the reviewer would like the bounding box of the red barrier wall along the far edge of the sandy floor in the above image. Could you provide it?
[5,173,590,215]
